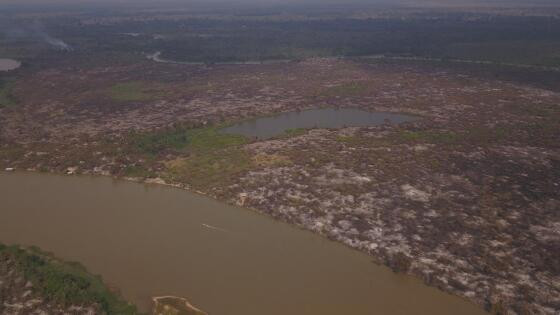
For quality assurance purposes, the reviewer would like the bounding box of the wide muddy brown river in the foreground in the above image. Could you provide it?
[0,172,484,315]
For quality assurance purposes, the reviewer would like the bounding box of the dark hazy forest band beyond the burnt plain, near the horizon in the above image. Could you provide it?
[5,12,560,66]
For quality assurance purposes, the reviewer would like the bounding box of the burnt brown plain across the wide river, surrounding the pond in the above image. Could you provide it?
[0,58,560,314]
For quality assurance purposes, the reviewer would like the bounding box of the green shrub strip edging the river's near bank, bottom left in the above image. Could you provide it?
[0,244,138,315]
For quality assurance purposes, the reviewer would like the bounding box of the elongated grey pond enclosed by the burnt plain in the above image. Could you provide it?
[222,108,418,139]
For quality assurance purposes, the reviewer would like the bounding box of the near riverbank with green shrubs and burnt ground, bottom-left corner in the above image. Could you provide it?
[0,243,138,315]
